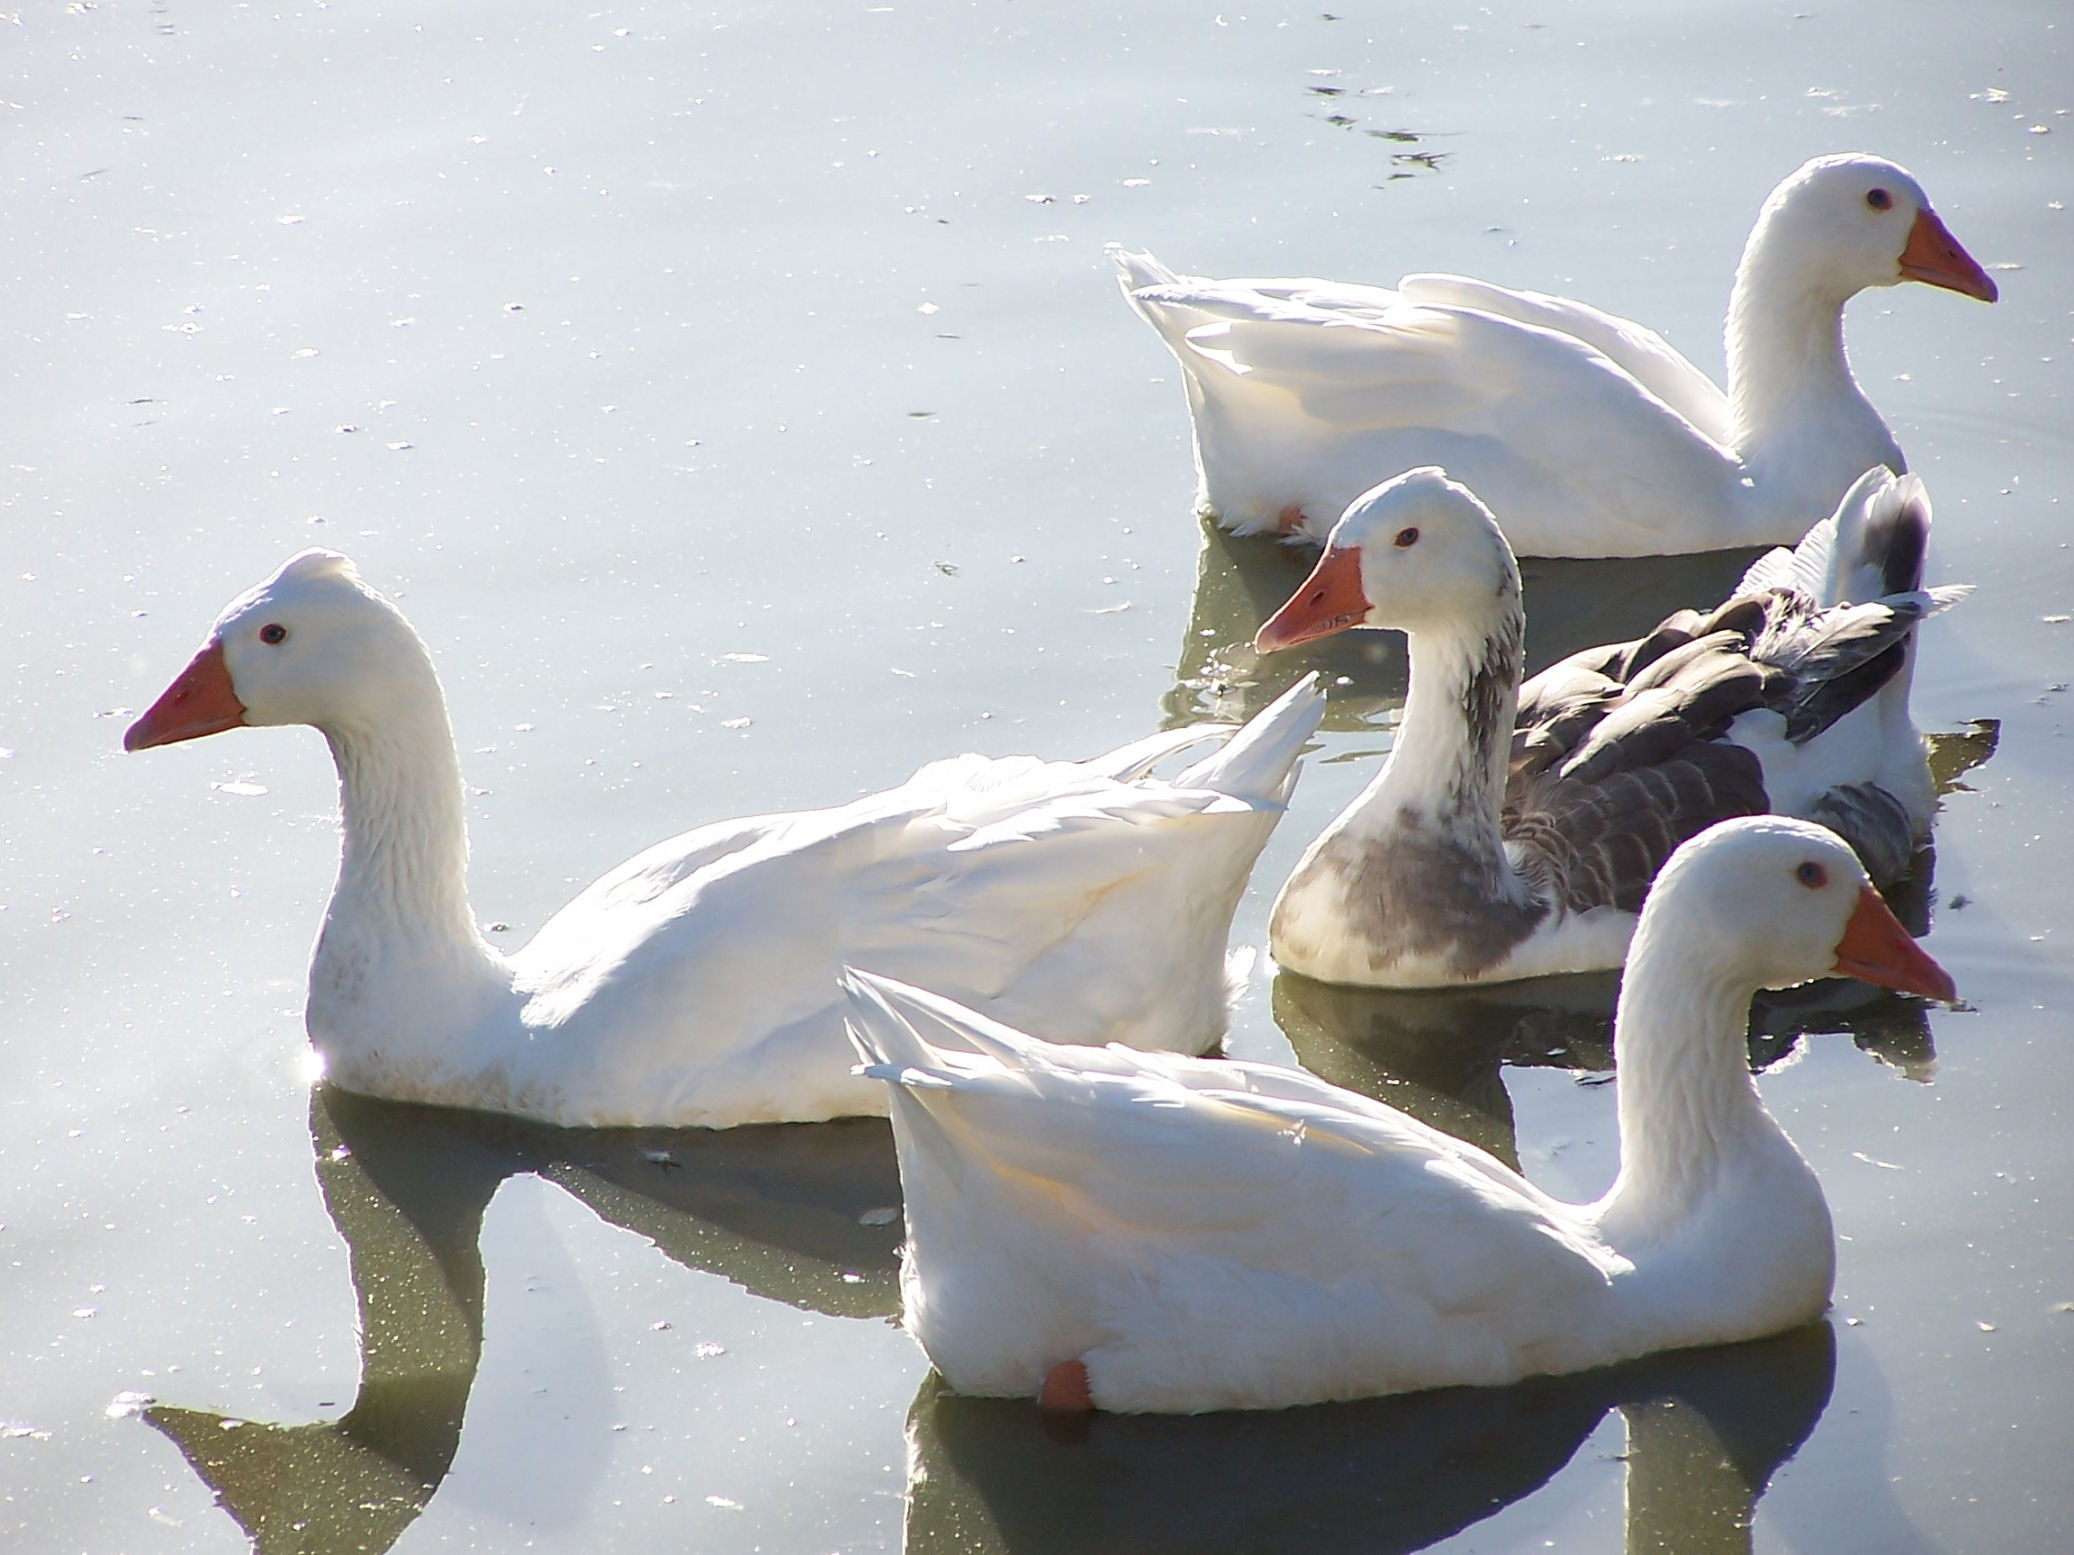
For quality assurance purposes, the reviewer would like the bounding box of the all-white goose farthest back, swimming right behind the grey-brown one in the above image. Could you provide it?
[1116,156,1995,556]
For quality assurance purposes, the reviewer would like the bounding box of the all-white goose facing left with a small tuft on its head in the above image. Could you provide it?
[124,552,1323,1128]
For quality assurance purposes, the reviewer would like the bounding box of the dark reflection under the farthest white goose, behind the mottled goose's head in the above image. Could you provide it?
[1159,518,1763,730]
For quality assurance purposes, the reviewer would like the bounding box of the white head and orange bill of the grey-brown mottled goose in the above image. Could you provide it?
[1253,464,1520,653]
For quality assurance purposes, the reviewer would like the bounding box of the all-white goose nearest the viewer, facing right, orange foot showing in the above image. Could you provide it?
[848,817,1954,1414]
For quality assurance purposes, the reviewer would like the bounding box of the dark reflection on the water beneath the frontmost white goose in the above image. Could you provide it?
[906,1323,1835,1555]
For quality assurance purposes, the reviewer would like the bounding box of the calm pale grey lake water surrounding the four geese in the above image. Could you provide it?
[0,0,2074,1555]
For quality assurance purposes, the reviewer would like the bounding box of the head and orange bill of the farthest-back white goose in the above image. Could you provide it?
[1742,153,1997,303]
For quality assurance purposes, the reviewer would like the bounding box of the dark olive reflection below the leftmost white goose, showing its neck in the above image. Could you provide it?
[143,1086,900,1555]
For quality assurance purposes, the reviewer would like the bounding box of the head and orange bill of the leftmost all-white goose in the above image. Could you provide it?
[122,549,438,751]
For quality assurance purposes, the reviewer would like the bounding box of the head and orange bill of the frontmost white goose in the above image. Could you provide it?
[1630,815,1956,1001]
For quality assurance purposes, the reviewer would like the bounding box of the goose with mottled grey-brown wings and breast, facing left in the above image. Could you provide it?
[1255,467,1966,987]
